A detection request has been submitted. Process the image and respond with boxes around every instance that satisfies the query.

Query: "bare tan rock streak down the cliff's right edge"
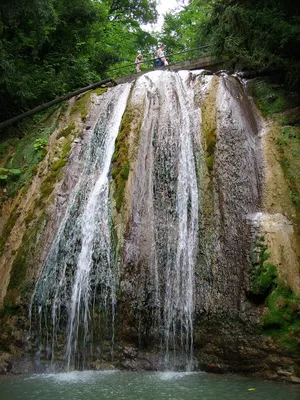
[261,121,300,295]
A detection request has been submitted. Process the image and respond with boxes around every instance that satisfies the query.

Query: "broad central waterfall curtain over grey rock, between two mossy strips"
[123,71,200,368]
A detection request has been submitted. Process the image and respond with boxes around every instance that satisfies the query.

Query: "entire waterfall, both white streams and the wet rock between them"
[31,71,261,370]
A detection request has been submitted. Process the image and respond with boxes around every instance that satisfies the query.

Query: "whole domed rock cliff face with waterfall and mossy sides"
[0,71,300,382]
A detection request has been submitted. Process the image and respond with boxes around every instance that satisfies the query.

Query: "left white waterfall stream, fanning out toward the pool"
[31,85,130,369]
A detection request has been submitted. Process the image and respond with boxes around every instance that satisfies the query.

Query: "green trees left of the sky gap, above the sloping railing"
[0,0,157,121]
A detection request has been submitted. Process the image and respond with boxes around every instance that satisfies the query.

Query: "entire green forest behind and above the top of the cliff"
[0,0,300,121]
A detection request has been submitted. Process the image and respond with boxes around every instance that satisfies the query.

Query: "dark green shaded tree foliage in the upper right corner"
[198,0,300,85]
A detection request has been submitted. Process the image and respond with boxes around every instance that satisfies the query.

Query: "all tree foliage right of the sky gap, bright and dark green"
[160,0,300,87]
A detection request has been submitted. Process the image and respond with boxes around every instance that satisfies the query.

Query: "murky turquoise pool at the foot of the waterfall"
[0,371,300,400]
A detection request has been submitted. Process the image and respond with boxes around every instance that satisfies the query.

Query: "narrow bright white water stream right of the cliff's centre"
[164,70,198,369]
